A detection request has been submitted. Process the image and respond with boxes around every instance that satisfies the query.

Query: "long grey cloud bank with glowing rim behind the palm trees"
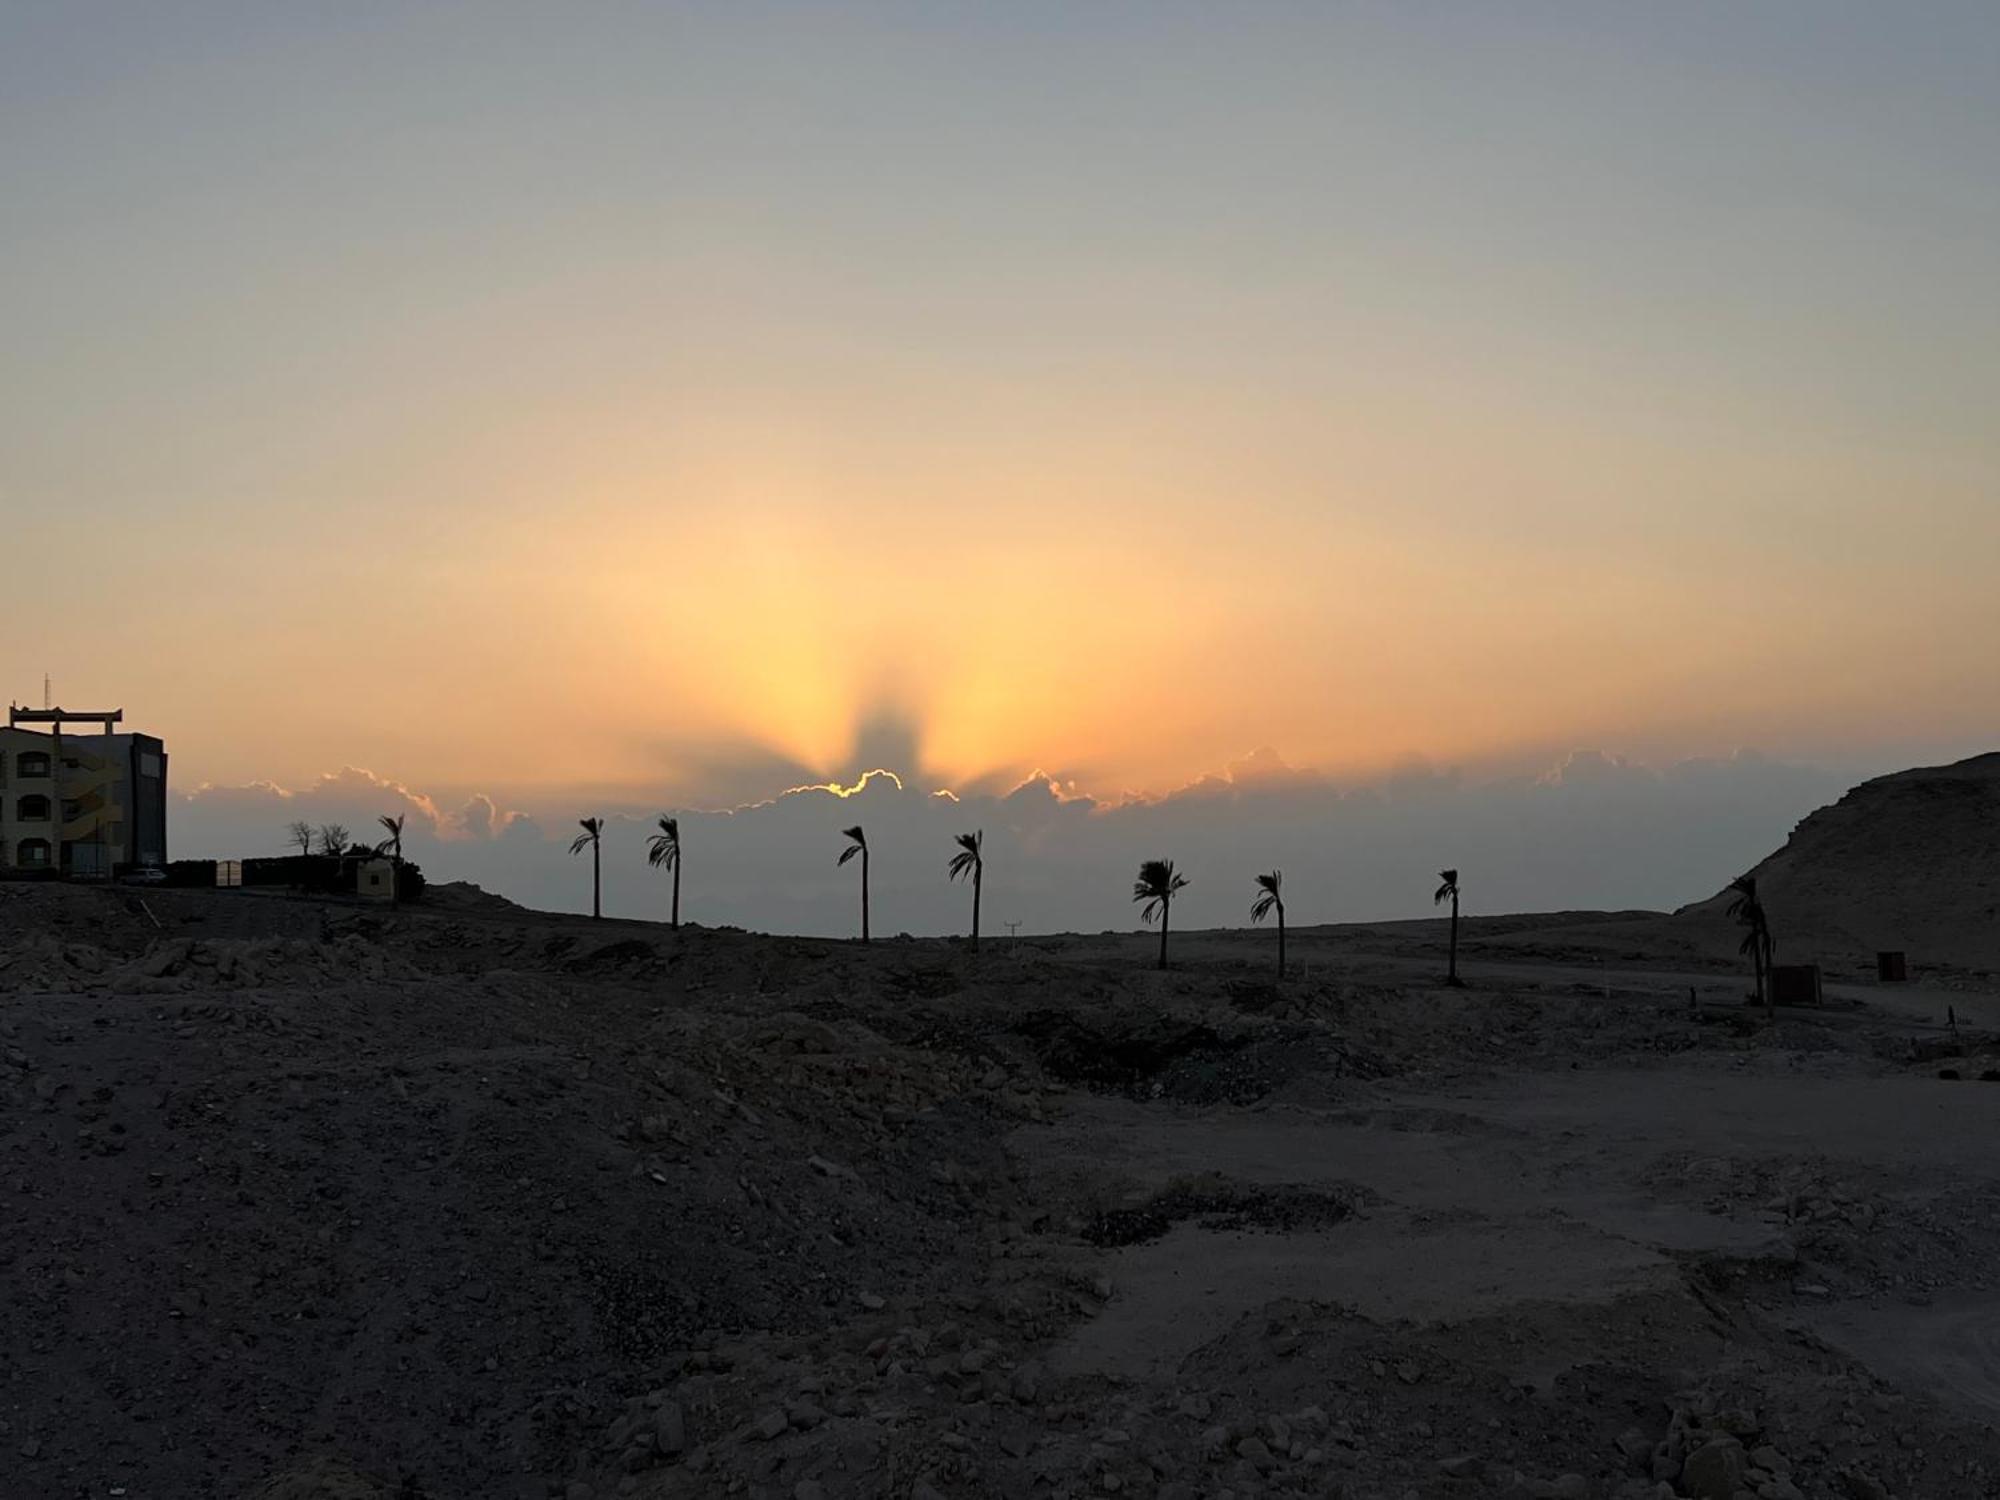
[170,750,1854,936]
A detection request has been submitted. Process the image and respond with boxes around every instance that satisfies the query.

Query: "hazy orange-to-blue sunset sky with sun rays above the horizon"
[0,0,2000,930]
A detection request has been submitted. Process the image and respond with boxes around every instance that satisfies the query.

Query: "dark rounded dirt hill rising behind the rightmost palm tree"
[1670,752,2000,972]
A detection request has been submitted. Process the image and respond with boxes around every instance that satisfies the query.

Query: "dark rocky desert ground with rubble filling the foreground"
[0,886,2000,1500]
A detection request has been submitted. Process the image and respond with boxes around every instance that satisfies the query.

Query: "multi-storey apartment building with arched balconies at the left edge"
[0,708,166,880]
